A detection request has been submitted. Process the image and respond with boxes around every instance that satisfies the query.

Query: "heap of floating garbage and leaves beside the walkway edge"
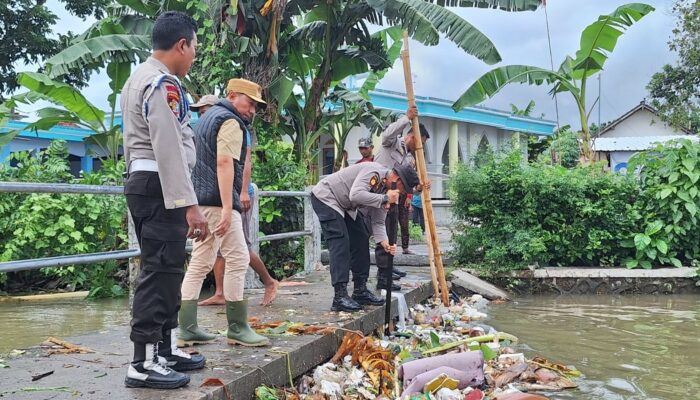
[256,295,580,400]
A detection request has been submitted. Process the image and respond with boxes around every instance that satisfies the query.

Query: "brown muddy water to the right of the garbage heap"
[487,295,700,400]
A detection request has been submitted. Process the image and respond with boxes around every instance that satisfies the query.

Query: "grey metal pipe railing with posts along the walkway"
[0,182,321,287]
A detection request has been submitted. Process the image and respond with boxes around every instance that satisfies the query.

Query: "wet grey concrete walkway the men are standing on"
[0,266,431,400]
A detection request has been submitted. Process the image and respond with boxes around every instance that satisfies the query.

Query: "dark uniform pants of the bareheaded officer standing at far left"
[124,171,187,343]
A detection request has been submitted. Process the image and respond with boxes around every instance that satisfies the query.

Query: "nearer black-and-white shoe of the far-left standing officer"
[124,343,190,389]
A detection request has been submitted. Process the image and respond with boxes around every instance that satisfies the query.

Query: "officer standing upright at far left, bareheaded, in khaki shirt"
[121,12,208,389]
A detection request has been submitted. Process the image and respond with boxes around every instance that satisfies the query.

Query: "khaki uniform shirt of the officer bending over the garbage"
[311,162,388,242]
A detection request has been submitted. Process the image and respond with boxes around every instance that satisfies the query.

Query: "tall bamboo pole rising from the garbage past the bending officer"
[401,31,450,306]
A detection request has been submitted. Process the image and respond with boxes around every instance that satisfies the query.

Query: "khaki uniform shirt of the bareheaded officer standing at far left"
[121,57,197,209]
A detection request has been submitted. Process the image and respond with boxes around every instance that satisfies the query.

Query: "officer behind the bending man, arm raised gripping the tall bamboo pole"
[374,107,430,291]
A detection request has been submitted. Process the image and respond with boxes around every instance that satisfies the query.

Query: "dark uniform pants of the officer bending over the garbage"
[311,195,369,286]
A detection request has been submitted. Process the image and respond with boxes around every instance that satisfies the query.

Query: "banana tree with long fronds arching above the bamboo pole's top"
[287,0,541,136]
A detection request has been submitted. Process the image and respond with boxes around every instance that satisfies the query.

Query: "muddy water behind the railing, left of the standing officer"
[0,297,130,354]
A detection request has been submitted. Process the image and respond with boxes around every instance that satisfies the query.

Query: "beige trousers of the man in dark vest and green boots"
[182,206,250,301]
